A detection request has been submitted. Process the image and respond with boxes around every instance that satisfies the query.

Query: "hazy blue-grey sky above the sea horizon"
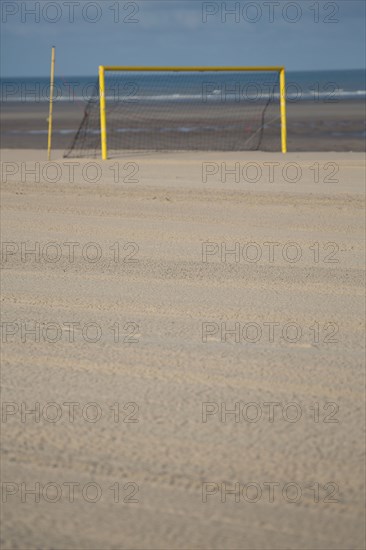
[1,0,366,77]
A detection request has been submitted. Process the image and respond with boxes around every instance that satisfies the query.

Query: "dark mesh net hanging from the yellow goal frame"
[65,67,285,158]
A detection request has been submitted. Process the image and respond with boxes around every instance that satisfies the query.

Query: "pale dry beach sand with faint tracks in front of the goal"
[2,150,365,550]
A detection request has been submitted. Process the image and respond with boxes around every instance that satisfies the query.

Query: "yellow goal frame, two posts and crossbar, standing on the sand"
[99,65,287,160]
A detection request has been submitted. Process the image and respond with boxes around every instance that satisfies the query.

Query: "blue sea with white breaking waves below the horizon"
[0,69,366,103]
